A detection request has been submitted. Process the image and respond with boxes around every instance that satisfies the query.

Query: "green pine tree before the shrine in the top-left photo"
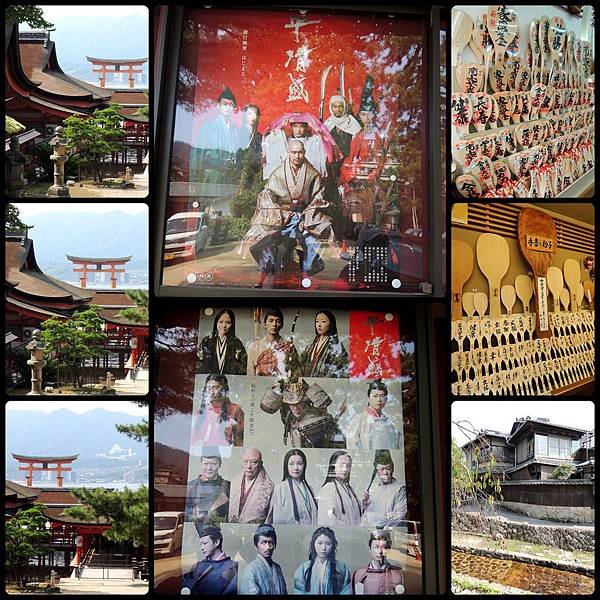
[64,104,125,182]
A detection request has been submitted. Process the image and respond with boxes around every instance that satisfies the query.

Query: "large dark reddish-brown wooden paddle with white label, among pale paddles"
[517,208,556,338]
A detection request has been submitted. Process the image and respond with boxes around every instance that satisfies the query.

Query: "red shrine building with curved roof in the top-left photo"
[4,25,150,174]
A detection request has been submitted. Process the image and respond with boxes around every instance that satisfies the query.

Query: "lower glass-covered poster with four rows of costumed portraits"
[155,306,422,595]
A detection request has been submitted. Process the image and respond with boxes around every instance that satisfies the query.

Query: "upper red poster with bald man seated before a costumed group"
[159,8,441,294]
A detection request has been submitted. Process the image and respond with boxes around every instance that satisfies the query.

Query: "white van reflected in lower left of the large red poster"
[165,212,209,261]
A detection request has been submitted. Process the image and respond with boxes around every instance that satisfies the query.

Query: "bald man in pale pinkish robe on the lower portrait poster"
[229,448,273,523]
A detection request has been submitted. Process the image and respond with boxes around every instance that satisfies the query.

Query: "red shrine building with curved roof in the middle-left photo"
[5,232,149,377]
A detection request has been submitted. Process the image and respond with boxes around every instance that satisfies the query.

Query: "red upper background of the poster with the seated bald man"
[178,9,427,141]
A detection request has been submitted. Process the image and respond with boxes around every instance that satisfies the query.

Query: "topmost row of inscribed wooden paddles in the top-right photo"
[452,5,592,92]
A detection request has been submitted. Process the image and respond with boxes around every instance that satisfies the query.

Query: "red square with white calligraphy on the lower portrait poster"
[350,310,400,379]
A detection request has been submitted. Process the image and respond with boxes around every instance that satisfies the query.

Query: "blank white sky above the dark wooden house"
[452,400,594,446]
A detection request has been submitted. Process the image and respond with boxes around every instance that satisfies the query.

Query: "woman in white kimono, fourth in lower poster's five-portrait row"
[318,450,362,527]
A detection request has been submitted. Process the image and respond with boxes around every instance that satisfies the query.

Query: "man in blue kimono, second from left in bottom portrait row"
[240,525,287,596]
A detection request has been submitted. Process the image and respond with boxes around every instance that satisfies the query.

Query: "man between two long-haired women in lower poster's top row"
[248,308,300,377]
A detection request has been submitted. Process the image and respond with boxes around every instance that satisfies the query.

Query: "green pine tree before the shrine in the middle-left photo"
[42,305,106,388]
